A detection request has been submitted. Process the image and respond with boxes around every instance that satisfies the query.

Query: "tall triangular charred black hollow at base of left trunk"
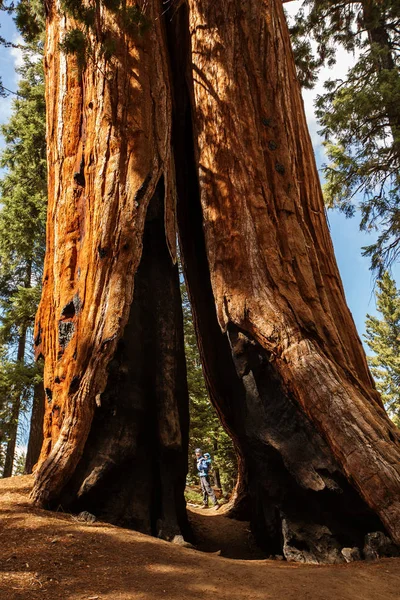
[50,181,189,539]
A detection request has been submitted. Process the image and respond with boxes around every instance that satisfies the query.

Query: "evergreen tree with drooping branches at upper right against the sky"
[292,0,400,274]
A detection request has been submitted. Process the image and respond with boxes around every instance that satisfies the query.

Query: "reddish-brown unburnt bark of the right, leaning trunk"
[184,0,400,542]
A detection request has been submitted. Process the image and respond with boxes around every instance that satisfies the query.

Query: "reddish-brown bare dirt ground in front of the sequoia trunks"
[0,476,400,600]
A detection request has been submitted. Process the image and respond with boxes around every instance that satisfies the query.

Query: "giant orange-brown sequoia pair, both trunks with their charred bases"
[32,0,400,561]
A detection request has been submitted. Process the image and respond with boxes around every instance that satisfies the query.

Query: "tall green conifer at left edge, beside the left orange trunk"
[0,27,47,477]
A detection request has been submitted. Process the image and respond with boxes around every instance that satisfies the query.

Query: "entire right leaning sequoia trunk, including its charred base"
[183,0,400,560]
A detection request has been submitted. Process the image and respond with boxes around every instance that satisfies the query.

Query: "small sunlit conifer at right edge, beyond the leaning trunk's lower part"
[364,272,400,427]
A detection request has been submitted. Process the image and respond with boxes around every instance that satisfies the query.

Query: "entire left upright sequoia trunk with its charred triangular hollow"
[29,1,188,537]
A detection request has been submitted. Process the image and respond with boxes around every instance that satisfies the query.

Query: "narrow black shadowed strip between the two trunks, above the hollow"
[167,4,244,454]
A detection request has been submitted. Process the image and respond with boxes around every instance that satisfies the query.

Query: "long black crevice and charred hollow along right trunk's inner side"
[167,5,383,562]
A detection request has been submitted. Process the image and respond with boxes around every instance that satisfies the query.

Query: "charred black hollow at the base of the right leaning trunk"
[228,326,390,563]
